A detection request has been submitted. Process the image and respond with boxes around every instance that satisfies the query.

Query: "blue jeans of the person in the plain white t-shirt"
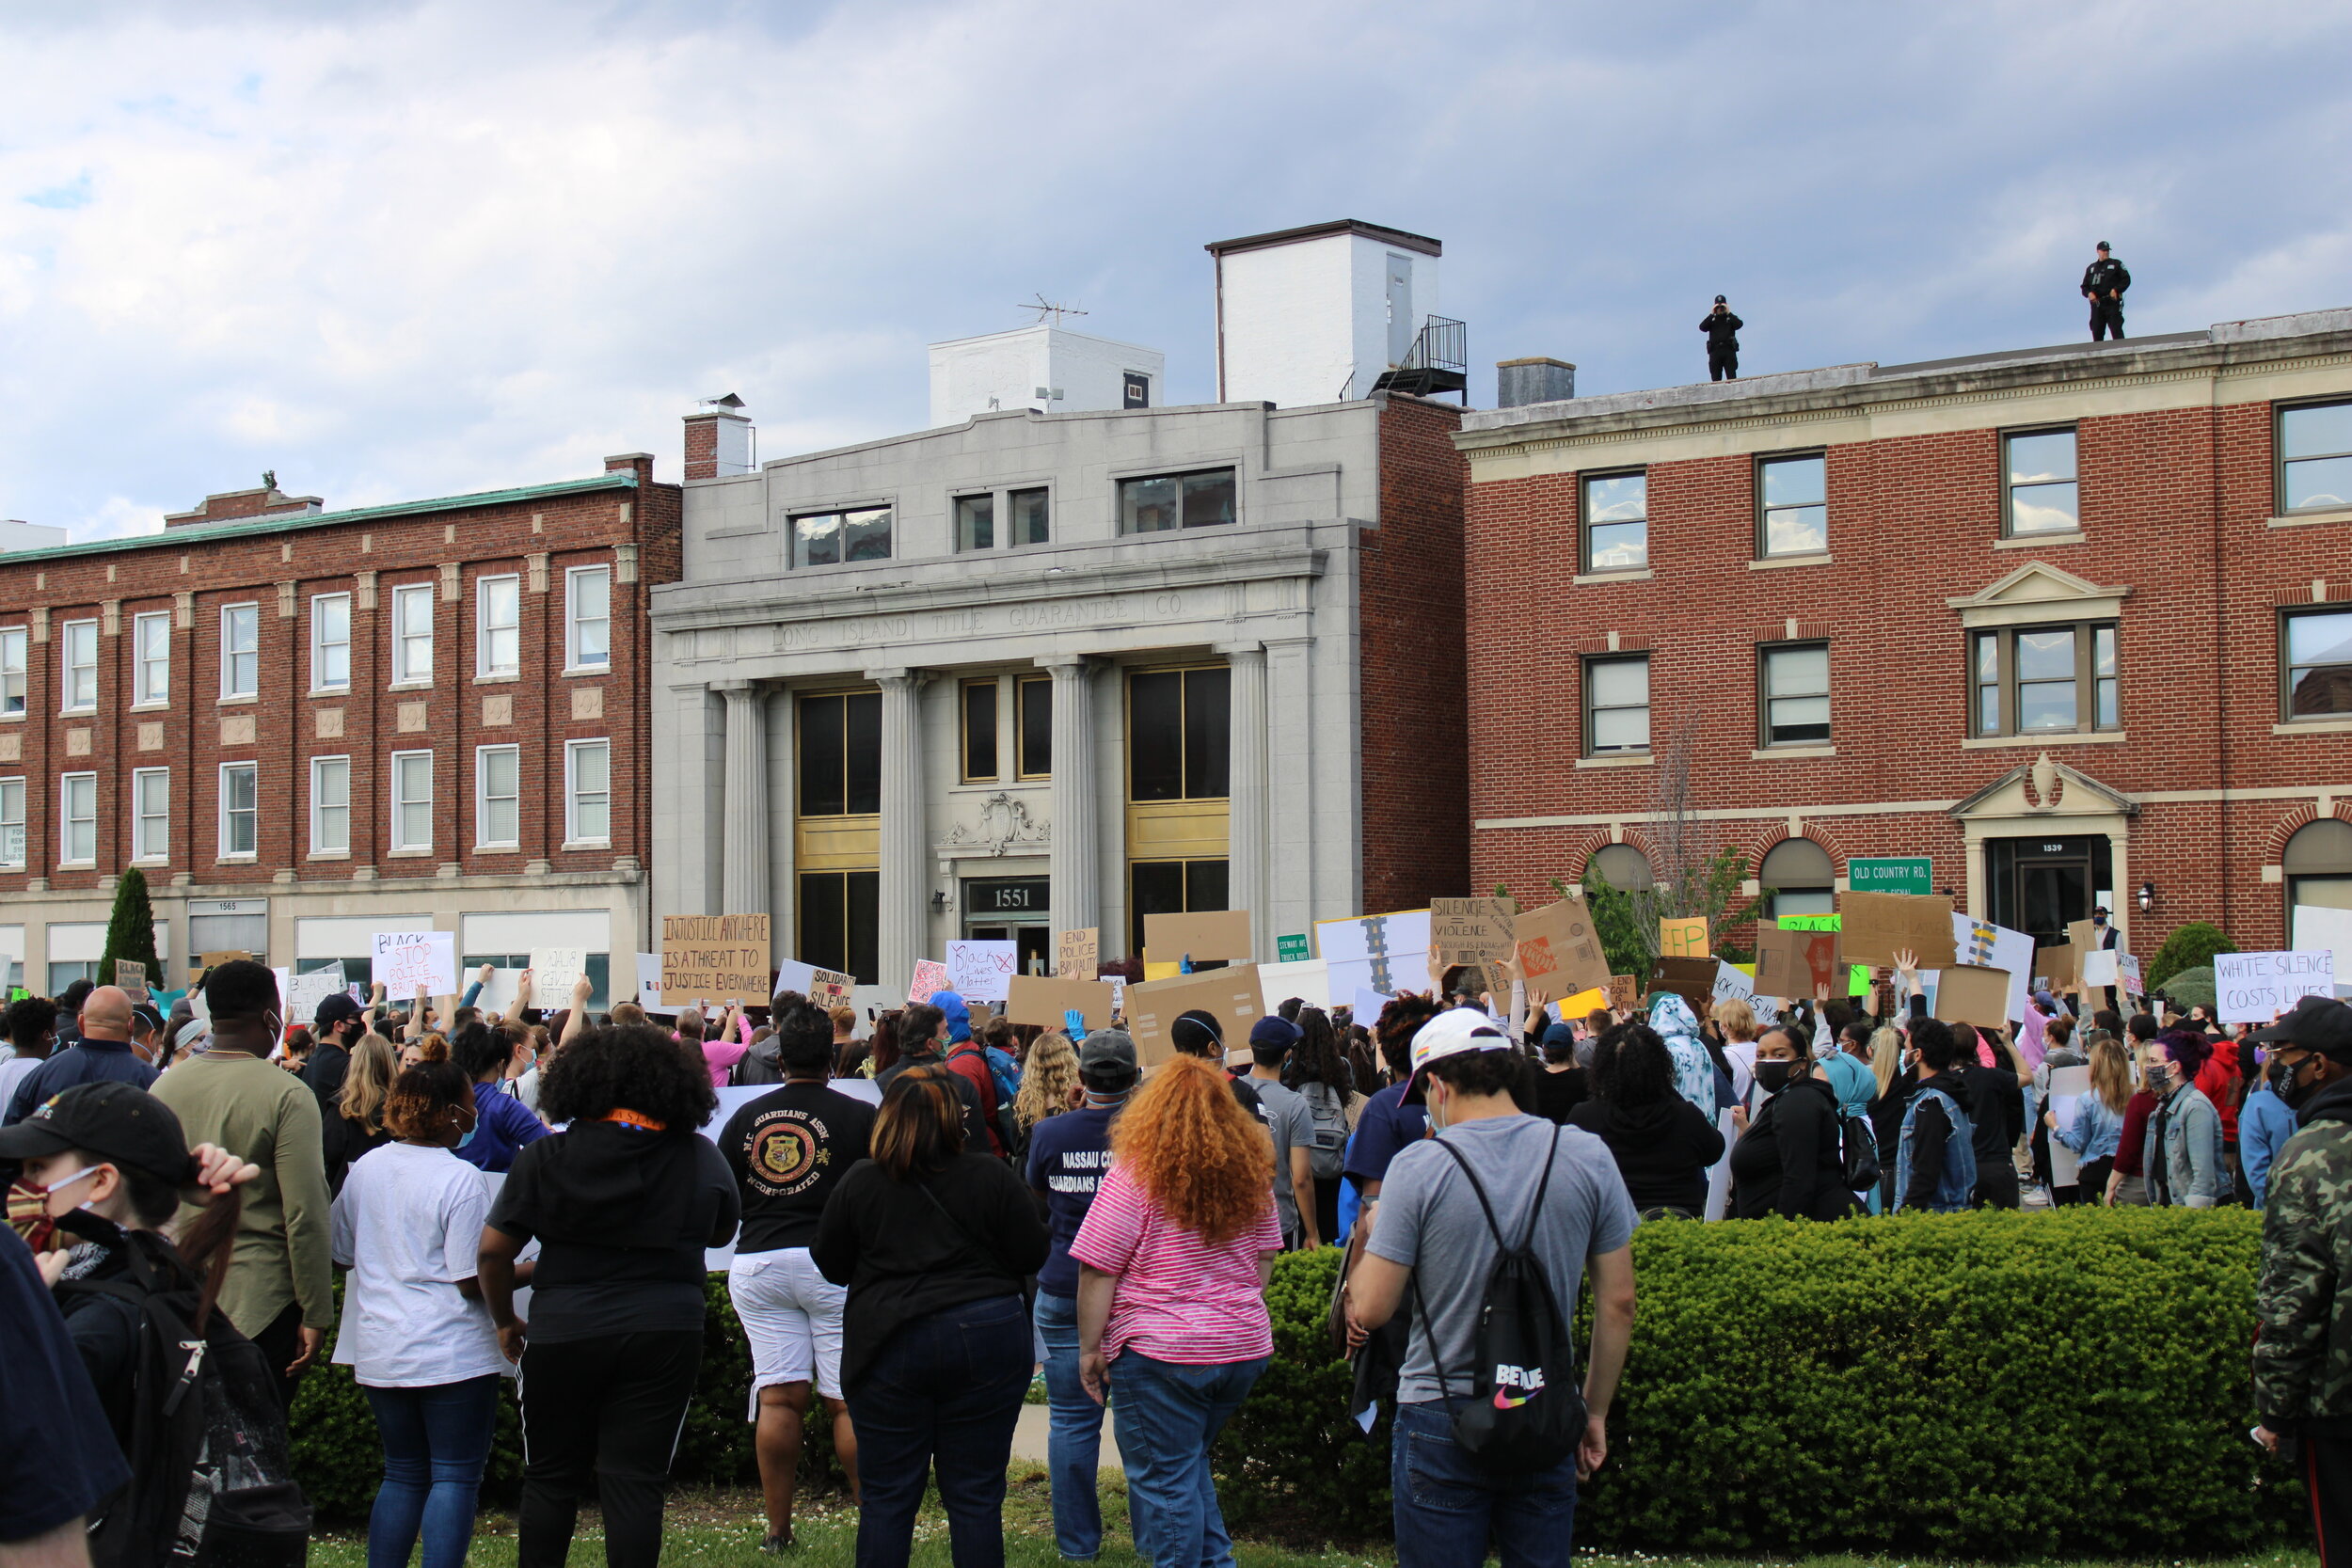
[367,1373,501,1568]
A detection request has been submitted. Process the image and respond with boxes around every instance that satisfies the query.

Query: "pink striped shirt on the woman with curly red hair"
[1071,1166,1282,1366]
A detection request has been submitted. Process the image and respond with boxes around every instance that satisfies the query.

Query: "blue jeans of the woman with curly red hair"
[1110,1350,1268,1568]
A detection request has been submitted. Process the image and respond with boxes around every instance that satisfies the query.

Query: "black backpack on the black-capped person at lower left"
[56,1232,310,1568]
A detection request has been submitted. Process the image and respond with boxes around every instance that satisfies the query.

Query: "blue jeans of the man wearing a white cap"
[1388,1399,1576,1568]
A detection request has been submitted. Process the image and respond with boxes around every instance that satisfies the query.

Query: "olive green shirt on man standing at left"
[153,1051,334,1336]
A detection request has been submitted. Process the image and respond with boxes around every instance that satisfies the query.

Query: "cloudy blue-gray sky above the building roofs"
[0,0,2352,538]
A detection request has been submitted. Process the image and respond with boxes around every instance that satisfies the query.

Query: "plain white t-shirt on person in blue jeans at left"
[334,1143,513,1389]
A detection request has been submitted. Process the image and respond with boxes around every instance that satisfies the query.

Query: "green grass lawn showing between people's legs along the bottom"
[310,1460,2319,1568]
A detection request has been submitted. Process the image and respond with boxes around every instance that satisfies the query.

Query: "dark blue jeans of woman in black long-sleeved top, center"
[850,1295,1035,1568]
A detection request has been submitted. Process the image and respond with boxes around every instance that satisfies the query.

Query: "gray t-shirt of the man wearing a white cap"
[1372,1117,1635,1403]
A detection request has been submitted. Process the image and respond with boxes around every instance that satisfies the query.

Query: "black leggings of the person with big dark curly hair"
[516,1328,704,1568]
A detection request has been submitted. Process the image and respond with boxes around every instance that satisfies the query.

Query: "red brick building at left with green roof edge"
[0,453,680,994]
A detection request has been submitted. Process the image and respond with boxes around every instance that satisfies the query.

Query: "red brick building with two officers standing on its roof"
[1456,310,2352,957]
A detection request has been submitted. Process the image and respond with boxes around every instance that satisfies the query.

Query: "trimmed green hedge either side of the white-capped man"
[1218,1209,2303,1559]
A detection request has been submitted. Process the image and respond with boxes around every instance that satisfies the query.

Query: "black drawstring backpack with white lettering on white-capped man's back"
[1414,1129,1585,1477]
